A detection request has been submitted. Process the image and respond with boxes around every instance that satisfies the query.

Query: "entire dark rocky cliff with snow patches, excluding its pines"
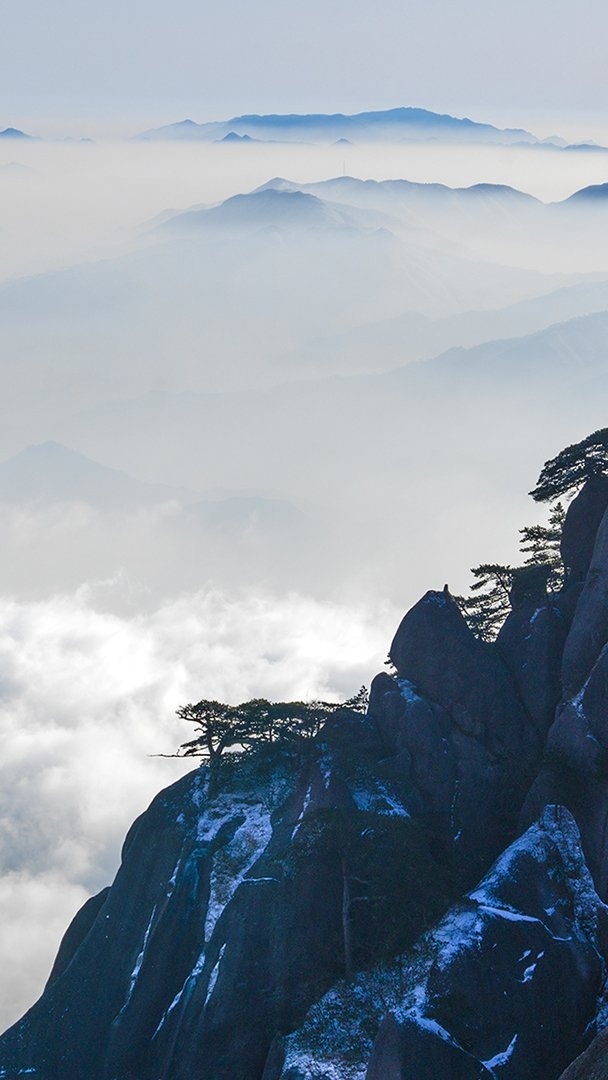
[0,478,608,1080]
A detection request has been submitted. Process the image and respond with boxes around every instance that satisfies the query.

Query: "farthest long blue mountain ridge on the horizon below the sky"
[136,107,562,147]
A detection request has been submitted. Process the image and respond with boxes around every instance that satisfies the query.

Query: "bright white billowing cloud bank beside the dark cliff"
[0,590,400,1028]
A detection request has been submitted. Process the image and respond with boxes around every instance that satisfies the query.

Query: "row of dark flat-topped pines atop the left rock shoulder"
[177,687,367,762]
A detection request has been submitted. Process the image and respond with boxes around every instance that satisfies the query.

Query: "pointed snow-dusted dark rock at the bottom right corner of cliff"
[274,807,607,1080]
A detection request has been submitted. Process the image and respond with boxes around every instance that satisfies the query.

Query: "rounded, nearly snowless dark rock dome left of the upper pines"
[369,592,541,885]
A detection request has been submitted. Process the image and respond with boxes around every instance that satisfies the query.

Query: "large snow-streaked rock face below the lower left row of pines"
[0,720,451,1080]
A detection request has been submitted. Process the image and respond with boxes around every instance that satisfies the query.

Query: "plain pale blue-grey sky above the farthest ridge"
[0,0,608,135]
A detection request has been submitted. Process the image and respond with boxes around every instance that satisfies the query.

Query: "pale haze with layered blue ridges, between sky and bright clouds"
[0,108,608,626]
